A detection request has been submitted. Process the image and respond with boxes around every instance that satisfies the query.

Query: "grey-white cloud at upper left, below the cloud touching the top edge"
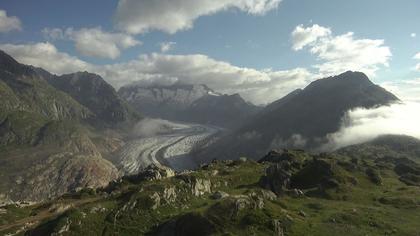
[42,27,141,59]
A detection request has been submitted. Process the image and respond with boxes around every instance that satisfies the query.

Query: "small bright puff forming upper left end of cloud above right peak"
[292,24,331,51]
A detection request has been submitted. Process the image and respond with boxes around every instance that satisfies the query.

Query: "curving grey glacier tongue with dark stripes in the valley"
[114,121,221,174]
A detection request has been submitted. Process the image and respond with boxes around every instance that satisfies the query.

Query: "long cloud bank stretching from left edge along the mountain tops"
[0,43,314,104]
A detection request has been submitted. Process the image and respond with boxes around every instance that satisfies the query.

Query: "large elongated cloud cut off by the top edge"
[114,0,281,34]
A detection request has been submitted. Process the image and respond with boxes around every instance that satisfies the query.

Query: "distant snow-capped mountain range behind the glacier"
[118,84,259,128]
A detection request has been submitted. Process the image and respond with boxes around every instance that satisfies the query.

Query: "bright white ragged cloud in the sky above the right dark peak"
[292,25,392,76]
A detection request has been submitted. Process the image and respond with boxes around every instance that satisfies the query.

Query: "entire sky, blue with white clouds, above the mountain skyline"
[0,0,420,104]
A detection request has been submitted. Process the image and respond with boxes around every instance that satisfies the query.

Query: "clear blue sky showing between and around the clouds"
[0,0,420,103]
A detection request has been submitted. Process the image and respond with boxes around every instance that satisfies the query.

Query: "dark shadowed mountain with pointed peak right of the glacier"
[201,72,399,161]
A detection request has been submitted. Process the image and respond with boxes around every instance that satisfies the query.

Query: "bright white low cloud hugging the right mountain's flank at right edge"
[323,103,420,150]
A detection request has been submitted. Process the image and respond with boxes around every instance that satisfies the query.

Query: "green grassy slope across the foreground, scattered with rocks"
[0,150,420,235]
